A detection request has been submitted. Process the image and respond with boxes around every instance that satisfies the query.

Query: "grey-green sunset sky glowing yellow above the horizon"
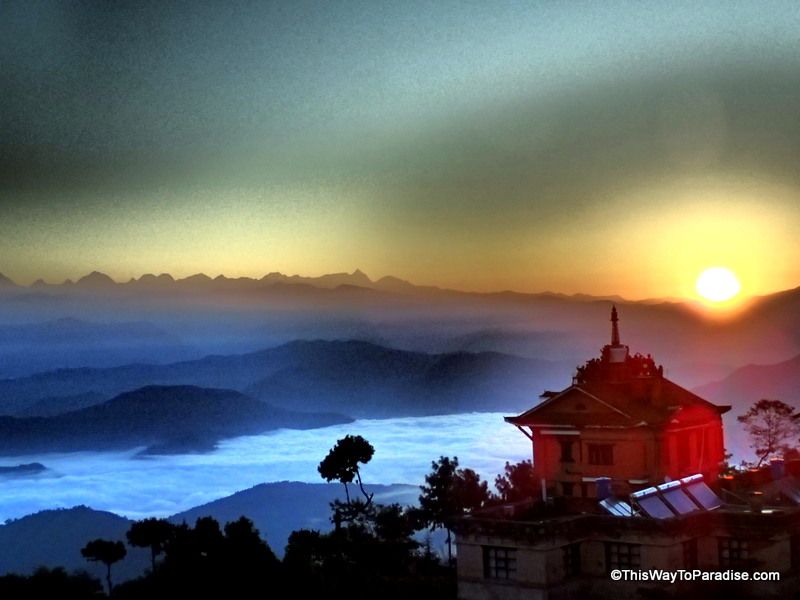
[0,0,800,299]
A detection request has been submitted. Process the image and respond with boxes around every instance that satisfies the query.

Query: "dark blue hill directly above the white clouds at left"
[0,386,351,455]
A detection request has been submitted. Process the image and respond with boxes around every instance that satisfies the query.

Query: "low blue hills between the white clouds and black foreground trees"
[0,481,419,582]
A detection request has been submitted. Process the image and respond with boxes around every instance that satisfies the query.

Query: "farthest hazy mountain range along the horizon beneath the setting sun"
[0,270,800,386]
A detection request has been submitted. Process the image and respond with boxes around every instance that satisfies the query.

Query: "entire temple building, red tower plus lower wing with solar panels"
[452,308,800,600]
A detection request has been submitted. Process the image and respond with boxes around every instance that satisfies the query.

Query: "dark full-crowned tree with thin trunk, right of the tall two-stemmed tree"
[419,456,490,563]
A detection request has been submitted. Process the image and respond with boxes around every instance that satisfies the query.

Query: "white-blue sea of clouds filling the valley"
[0,413,531,521]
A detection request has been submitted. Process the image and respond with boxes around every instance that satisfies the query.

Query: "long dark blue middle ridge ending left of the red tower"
[0,341,571,420]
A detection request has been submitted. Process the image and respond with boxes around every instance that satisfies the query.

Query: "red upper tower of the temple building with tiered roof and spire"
[506,307,730,498]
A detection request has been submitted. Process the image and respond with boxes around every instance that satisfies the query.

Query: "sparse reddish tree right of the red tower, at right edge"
[736,398,798,467]
